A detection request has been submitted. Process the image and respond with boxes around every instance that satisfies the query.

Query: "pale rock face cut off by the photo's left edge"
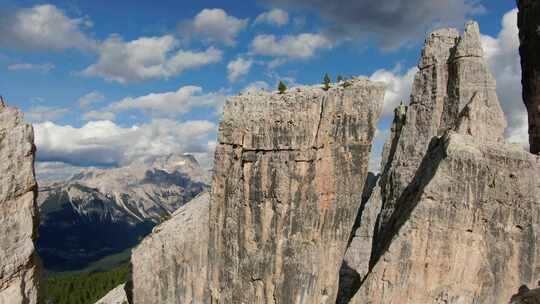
[0,98,41,304]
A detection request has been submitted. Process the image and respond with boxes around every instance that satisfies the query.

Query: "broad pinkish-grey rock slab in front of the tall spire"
[350,131,540,304]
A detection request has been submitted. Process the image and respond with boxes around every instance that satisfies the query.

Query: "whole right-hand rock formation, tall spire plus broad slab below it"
[342,23,540,304]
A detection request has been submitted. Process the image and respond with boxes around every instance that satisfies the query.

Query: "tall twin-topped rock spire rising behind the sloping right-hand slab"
[345,23,506,296]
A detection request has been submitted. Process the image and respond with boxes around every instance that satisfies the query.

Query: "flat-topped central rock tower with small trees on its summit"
[208,78,384,304]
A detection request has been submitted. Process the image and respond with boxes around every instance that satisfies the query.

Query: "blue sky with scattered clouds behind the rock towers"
[0,0,526,175]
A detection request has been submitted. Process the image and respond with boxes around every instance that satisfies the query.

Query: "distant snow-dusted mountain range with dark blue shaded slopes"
[37,155,210,272]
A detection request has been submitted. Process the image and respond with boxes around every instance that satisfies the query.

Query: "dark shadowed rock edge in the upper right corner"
[517,0,540,154]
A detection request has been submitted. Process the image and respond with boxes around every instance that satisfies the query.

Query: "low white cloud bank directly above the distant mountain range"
[34,119,216,166]
